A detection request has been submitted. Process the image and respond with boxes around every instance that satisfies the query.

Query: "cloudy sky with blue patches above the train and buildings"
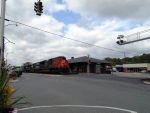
[1,0,150,66]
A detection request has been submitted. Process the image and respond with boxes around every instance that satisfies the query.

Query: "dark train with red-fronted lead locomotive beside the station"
[23,56,70,74]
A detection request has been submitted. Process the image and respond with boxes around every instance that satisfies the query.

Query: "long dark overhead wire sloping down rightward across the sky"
[5,19,136,54]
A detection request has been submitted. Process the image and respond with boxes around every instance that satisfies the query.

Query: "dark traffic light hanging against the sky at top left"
[34,1,43,16]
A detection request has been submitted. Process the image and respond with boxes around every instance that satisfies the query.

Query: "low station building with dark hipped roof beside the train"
[68,56,111,73]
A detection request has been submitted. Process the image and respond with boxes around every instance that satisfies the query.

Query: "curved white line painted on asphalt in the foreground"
[18,105,137,113]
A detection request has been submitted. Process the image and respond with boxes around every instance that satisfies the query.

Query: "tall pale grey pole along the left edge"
[0,0,6,73]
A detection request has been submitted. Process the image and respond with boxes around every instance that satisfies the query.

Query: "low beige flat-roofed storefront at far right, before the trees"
[123,63,150,72]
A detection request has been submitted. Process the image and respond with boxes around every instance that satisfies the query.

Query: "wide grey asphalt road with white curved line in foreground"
[11,73,150,113]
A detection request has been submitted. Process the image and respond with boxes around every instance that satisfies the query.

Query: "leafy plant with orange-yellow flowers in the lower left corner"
[0,69,30,113]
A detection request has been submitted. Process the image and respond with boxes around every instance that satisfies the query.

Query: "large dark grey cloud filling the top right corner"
[63,0,150,20]
